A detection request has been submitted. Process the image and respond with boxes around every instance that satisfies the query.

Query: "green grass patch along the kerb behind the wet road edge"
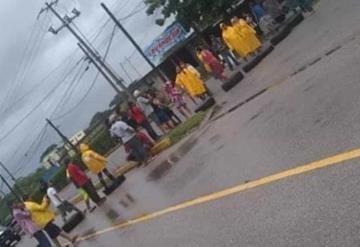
[167,112,206,145]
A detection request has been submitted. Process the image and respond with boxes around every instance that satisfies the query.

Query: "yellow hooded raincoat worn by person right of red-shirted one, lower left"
[80,143,107,174]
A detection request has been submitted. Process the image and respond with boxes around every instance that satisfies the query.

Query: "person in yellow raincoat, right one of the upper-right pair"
[231,17,262,52]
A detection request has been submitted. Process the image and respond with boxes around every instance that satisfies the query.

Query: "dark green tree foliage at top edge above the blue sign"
[145,0,236,30]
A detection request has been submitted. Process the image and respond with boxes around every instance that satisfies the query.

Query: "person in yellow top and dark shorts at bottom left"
[24,195,78,247]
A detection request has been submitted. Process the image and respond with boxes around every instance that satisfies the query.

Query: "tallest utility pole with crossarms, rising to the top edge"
[40,0,132,97]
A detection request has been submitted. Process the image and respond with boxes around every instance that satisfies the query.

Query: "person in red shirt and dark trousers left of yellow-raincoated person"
[65,159,106,206]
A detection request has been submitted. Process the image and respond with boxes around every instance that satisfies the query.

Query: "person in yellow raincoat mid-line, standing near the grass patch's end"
[175,63,207,99]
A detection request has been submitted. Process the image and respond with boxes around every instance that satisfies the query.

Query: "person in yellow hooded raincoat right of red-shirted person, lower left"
[80,143,116,189]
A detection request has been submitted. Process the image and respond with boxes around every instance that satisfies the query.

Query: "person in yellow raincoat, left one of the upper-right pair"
[220,23,251,60]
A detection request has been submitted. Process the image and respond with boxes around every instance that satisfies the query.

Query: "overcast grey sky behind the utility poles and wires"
[0,0,172,180]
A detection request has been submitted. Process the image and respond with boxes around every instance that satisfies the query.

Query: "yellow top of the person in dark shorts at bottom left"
[24,197,55,228]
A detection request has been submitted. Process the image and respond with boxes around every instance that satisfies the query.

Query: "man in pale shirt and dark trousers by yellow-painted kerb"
[109,114,149,165]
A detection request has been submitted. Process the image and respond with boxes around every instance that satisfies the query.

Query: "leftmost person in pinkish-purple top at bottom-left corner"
[11,202,51,247]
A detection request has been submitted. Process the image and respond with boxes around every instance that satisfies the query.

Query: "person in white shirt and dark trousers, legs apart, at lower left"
[46,182,82,223]
